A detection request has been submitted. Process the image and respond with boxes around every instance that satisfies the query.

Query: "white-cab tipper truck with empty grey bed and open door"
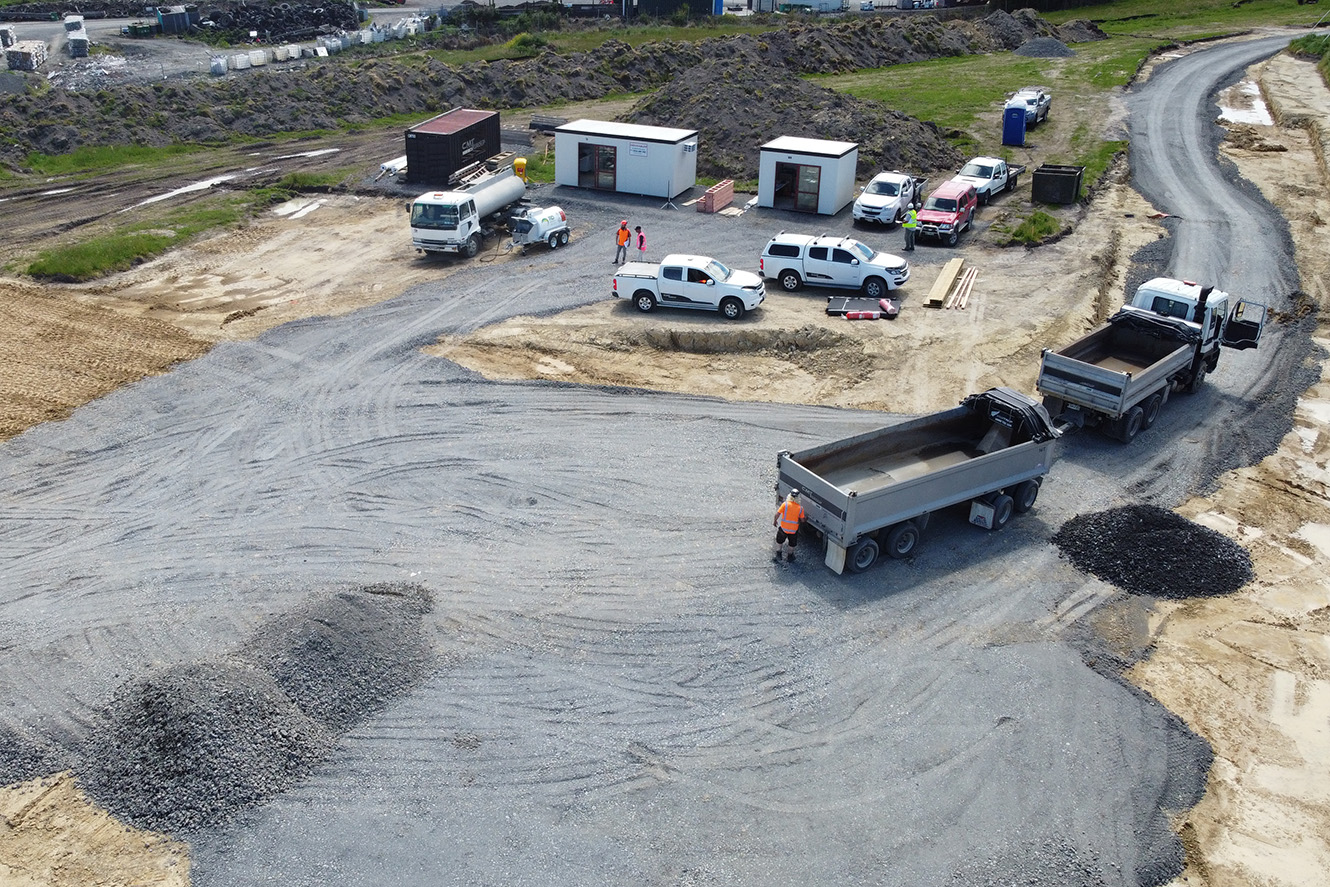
[1035,278,1266,443]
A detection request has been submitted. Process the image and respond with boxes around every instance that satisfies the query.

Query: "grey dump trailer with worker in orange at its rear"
[775,388,1060,573]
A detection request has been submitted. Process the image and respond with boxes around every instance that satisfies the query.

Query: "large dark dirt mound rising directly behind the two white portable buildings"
[628,59,962,180]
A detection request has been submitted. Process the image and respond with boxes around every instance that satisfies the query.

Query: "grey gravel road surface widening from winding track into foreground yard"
[0,31,1309,887]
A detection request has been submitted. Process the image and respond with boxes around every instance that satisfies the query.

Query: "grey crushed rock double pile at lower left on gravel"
[80,585,431,832]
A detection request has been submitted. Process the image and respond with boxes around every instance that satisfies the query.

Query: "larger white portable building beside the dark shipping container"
[555,120,697,199]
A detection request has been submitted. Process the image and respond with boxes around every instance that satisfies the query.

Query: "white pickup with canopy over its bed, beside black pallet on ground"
[758,231,910,299]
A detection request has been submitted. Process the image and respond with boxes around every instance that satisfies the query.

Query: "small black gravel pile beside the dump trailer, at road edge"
[1053,505,1253,598]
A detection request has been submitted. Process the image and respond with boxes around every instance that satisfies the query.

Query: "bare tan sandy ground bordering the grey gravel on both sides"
[0,39,1330,884]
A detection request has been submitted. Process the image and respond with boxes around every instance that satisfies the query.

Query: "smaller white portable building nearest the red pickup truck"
[757,136,859,215]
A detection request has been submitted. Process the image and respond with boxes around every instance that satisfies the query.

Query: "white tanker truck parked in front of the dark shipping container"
[411,165,527,258]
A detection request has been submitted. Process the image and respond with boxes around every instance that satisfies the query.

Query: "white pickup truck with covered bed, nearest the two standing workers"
[612,255,766,320]
